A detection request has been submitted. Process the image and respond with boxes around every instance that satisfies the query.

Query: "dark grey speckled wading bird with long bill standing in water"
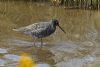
[13,19,66,46]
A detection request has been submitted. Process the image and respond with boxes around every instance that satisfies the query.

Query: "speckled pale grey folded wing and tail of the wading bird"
[13,22,49,35]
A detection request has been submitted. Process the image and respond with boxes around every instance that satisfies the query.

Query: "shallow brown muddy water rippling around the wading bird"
[0,2,100,67]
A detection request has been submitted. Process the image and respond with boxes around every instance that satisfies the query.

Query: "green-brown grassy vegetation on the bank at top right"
[52,0,100,9]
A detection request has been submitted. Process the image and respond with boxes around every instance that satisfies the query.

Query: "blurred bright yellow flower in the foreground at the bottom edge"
[18,53,35,67]
